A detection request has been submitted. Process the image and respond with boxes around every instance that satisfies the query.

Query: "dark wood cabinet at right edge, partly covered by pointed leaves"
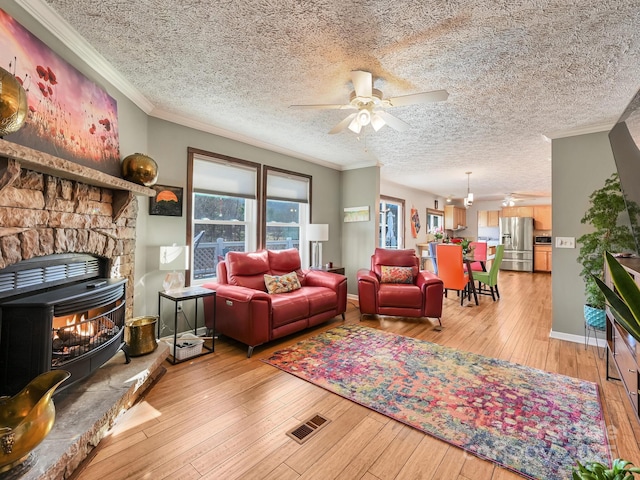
[605,258,640,422]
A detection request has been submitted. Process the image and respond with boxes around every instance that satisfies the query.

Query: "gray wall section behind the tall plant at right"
[551,132,616,341]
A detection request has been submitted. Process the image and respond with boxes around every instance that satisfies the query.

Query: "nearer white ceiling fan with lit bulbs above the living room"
[290,70,449,134]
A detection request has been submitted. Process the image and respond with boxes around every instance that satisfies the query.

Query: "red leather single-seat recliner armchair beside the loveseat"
[357,248,444,326]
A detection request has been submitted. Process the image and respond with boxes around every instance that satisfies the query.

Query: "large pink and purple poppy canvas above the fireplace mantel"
[0,9,121,177]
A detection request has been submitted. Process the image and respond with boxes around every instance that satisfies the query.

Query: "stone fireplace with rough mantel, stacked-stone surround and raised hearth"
[0,139,168,479]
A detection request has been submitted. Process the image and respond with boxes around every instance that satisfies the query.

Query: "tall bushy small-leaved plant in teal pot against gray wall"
[577,173,640,309]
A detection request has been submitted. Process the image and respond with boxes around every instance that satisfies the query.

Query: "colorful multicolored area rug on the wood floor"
[264,325,611,480]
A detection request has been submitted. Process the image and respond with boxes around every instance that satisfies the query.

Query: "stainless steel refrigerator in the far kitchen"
[500,217,533,272]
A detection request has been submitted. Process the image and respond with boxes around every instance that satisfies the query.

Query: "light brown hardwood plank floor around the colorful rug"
[72,272,640,480]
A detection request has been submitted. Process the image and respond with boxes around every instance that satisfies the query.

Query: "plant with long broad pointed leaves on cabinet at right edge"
[593,252,640,342]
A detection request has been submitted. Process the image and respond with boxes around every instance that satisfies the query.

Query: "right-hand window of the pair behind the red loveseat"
[263,167,311,265]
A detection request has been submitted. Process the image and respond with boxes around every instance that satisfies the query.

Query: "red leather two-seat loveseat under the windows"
[203,249,347,357]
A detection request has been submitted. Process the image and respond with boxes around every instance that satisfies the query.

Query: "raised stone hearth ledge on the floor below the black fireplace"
[0,342,169,480]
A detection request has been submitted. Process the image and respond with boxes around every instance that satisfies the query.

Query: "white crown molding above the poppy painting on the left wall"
[15,0,153,114]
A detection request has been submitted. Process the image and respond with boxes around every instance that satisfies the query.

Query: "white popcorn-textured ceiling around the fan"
[30,0,640,199]
